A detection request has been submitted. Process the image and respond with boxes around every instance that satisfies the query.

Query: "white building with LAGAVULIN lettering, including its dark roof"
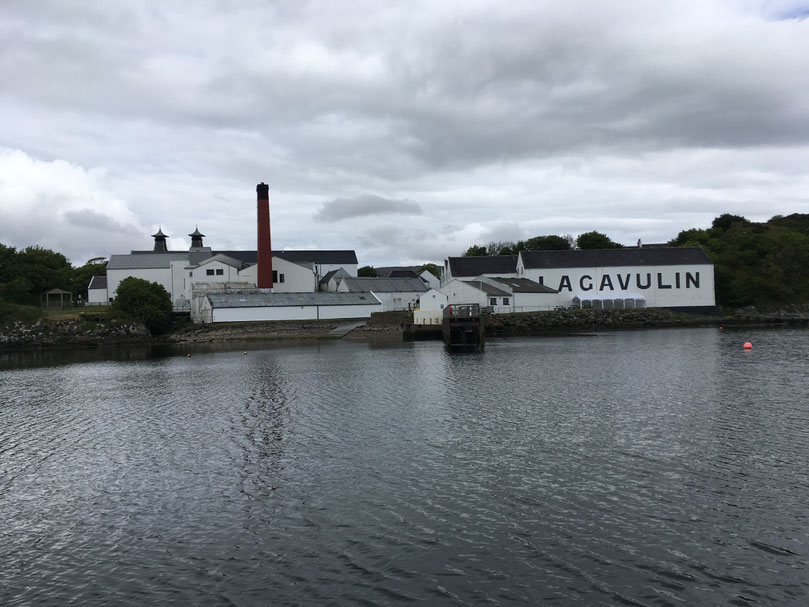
[516,247,716,313]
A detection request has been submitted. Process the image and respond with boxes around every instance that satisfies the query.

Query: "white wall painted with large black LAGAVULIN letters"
[522,264,716,308]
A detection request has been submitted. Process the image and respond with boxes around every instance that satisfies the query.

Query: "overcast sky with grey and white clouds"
[0,0,809,266]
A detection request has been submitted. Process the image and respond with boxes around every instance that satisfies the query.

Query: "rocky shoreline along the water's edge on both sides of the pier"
[0,305,809,349]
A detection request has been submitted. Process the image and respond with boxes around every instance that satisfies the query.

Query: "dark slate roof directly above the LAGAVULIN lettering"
[520,247,713,269]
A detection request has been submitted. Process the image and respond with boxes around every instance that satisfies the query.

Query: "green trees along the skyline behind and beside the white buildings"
[0,213,809,308]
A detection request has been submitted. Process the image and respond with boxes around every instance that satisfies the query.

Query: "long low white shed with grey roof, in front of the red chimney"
[191,291,382,323]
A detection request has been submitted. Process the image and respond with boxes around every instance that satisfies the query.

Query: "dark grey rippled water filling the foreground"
[0,329,809,605]
